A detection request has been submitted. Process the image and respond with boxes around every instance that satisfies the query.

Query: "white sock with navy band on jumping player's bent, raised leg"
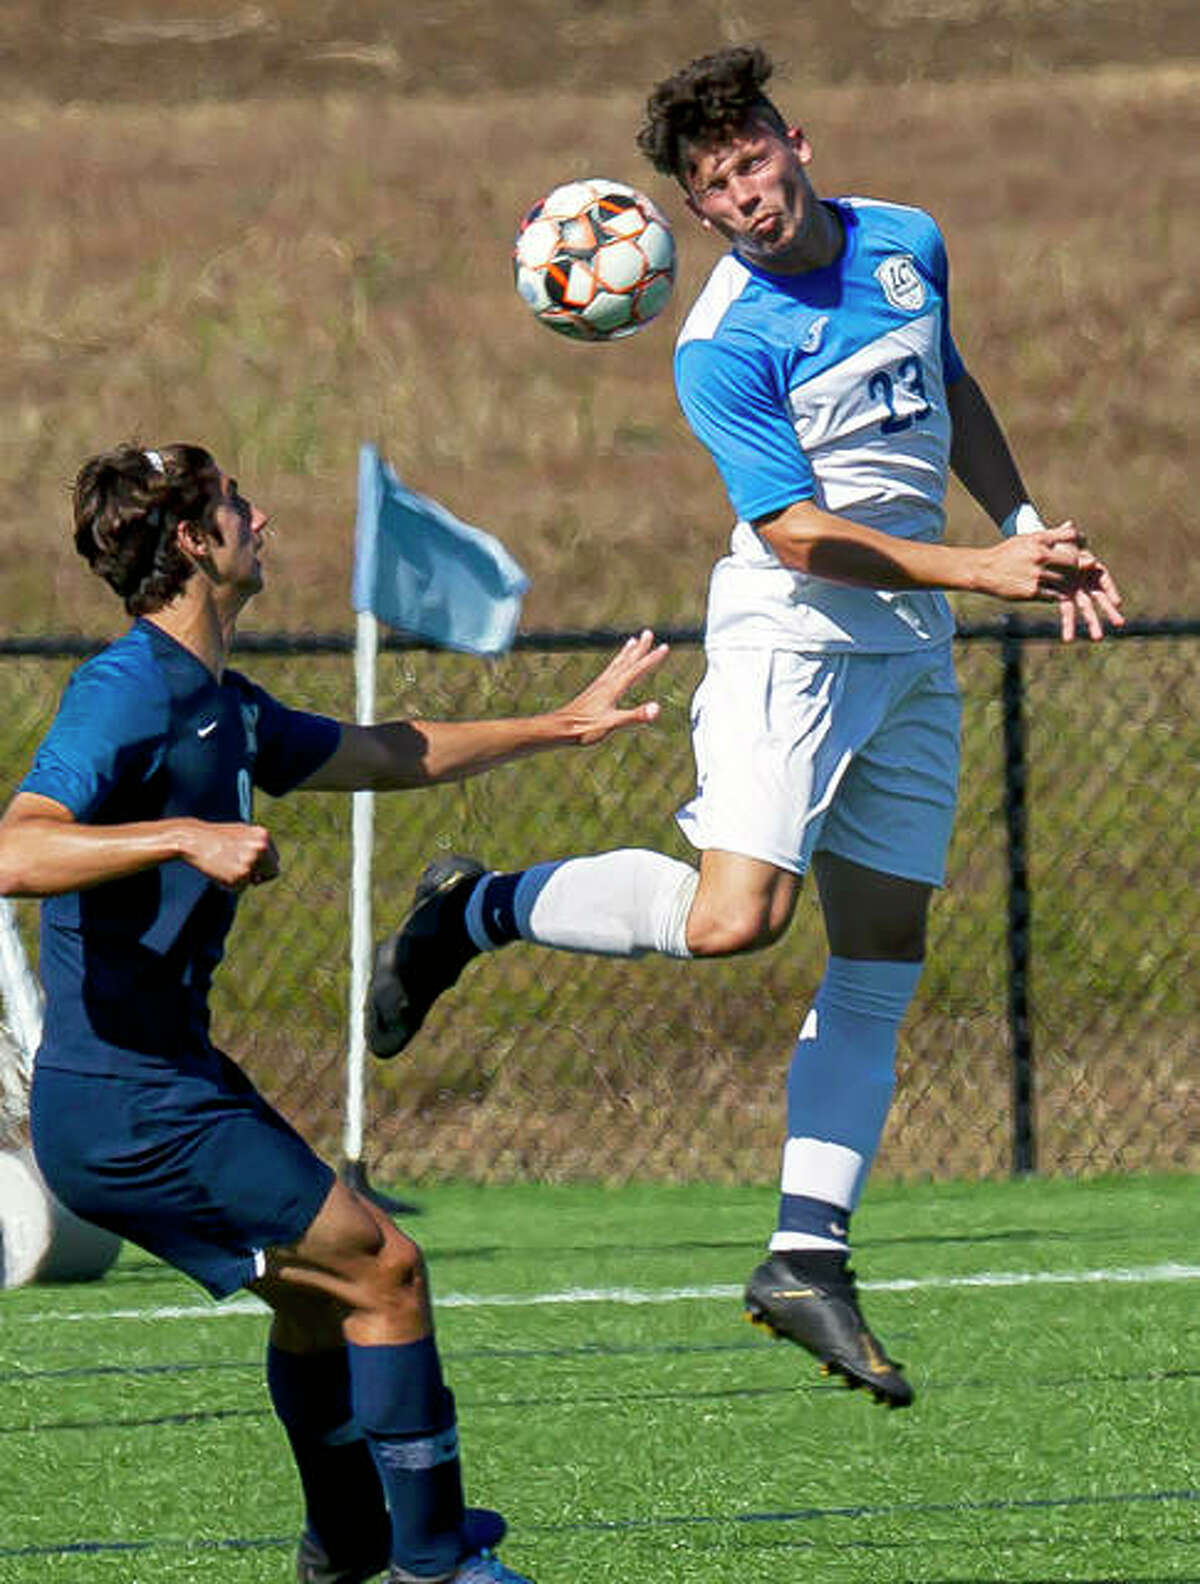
[465,847,700,957]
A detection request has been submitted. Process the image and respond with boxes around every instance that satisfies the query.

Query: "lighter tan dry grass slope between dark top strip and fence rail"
[0,52,1200,632]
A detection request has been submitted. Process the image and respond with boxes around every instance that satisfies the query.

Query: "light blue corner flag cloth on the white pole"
[351,445,529,654]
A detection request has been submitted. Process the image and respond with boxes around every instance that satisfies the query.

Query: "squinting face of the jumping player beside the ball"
[687,120,817,271]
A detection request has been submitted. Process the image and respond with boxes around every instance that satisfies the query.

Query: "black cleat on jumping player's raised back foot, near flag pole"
[367,852,486,1057]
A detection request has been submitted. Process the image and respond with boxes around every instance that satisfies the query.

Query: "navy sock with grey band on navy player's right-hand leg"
[348,1337,464,1579]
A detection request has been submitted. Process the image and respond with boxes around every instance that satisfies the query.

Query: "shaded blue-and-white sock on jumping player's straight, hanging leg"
[771,957,921,1248]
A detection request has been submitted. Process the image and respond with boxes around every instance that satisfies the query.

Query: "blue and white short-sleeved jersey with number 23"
[674,198,964,653]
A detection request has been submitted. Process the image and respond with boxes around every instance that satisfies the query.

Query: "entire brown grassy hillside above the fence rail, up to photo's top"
[0,0,1200,634]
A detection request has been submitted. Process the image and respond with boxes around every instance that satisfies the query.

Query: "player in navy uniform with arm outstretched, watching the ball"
[0,445,665,1584]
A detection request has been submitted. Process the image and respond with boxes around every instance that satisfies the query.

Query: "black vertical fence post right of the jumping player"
[1001,615,1037,1177]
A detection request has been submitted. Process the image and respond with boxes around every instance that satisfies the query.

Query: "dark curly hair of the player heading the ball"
[638,44,787,187]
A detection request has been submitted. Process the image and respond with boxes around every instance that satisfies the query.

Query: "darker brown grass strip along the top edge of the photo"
[0,0,1200,103]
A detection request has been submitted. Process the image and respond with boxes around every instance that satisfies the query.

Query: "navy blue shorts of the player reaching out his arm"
[30,1052,334,1297]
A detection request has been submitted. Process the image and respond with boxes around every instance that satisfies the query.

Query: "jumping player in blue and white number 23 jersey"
[369,48,1121,1407]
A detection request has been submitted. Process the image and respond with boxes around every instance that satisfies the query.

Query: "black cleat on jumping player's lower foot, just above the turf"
[746,1248,913,1408]
